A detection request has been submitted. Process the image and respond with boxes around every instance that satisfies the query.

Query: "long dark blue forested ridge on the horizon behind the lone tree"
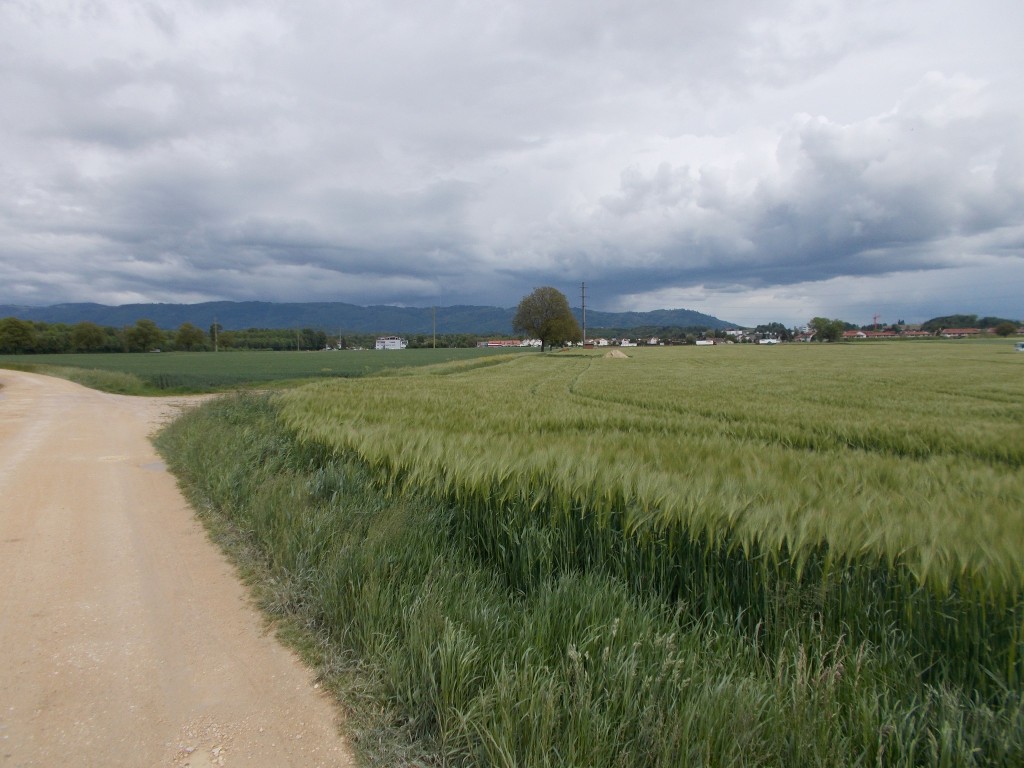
[0,301,733,335]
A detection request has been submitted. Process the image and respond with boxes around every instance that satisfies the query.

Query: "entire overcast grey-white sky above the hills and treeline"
[0,0,1024,326]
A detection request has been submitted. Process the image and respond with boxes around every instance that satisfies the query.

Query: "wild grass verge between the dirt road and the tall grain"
[158,395,1024,766]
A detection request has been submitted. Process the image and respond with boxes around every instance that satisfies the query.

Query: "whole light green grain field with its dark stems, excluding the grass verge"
[284,343,1024,685]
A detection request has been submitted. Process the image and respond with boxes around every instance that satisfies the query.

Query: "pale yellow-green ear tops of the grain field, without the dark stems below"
[285,345,1024,606]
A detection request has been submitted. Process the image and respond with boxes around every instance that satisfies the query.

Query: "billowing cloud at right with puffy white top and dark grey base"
[585,71,1024,313]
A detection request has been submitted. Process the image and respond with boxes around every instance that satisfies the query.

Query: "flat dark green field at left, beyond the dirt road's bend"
[0,349,520,393]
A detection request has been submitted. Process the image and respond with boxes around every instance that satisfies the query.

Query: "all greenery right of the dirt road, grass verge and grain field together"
[160,342,1024,766]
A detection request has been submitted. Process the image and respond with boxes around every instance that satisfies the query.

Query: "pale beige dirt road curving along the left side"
[0,371,353,768]
